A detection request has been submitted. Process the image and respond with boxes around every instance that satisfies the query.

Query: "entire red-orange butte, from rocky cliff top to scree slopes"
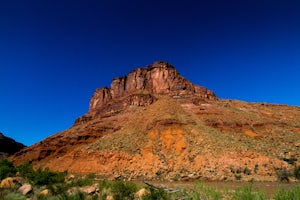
[12,62,300,180]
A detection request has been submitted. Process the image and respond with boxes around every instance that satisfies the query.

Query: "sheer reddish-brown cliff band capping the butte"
[89,61,217,113]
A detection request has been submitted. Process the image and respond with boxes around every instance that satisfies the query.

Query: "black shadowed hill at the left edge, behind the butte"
[0,132,25,159]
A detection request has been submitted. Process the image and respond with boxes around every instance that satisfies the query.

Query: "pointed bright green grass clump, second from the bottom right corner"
[233,183,267,200]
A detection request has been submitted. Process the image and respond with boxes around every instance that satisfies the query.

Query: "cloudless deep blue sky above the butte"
[0,0,300,145]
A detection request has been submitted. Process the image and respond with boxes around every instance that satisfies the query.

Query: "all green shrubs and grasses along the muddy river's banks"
[0,160,300,200]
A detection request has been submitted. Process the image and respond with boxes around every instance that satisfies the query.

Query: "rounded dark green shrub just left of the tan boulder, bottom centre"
[111,181,137,200]
